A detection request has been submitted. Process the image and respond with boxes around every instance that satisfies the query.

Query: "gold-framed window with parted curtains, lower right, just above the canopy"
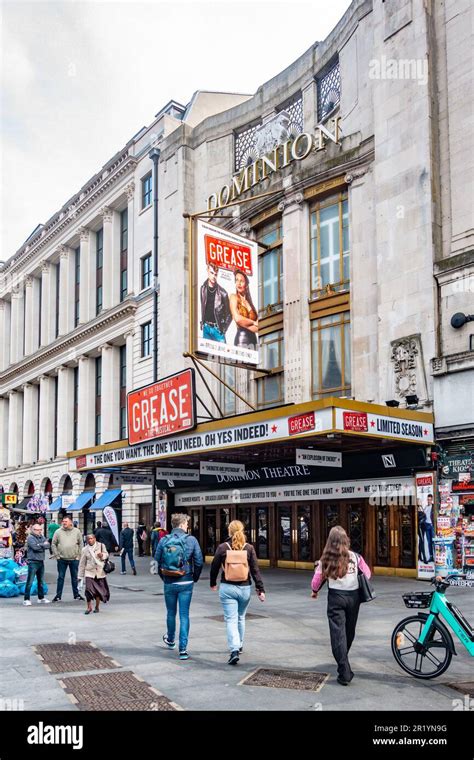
[311,311,351,398]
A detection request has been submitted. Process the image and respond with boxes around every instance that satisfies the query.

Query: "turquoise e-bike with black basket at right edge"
[392,575,474,679]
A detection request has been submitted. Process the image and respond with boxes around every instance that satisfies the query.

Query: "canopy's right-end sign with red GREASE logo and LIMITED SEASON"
[336,408,434,443]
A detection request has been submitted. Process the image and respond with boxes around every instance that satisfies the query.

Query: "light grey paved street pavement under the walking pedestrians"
[0,558,474,711]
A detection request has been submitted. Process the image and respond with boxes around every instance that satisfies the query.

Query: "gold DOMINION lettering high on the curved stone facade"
[207,116,340,212]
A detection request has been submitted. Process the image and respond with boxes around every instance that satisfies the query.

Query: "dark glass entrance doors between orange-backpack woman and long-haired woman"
[276,503,314,568]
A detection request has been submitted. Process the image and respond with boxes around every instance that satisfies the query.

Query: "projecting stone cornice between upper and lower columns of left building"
[0,299,137,394]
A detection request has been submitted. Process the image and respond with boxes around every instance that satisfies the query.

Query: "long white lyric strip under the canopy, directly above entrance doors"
[175,478,413,507]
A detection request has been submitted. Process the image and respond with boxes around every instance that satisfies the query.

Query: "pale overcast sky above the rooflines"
[0,0,350,260]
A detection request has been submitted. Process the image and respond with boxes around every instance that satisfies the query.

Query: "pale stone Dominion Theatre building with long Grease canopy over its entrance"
[64,0,460,574]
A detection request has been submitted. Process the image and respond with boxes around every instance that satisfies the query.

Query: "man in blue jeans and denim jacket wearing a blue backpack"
[155,514,203,660]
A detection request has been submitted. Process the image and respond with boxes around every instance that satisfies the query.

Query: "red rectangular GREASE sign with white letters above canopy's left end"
[128,369,196,445]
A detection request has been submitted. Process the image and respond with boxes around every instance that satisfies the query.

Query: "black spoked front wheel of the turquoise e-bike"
[392,615,453,680]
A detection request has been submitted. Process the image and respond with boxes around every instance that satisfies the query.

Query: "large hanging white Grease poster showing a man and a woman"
[197,220,259,365]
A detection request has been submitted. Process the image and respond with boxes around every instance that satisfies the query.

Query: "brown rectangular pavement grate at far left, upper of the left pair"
[33,641,120,673]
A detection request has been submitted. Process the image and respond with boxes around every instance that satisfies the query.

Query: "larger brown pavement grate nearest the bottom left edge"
[58,670,182,712]
